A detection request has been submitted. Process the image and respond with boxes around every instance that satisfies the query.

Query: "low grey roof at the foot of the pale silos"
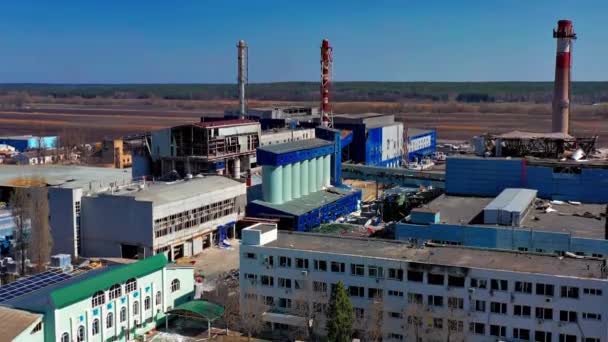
[253,187,354,216]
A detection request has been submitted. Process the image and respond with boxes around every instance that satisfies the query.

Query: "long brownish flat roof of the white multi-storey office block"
[264,231,606,279]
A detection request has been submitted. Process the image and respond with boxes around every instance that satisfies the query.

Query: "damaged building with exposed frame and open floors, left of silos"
[150,119,261,178]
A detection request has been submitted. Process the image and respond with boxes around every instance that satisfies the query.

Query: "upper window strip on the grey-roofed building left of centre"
[154,198,236,238]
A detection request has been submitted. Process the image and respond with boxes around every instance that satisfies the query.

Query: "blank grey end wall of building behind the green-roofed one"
[81,194,154,257]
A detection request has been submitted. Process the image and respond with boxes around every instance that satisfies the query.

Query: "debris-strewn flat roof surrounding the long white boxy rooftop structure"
[424,194,606,239]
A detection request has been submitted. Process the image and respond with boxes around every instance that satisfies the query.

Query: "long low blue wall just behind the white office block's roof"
[395,223,608,256]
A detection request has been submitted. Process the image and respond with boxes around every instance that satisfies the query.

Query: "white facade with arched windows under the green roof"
[52,267,194,342]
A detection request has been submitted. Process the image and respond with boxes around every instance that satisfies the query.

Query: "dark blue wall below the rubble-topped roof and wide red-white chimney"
[446,157,608,203]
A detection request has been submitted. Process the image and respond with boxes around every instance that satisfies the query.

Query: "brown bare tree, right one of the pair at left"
[29,187,53,272]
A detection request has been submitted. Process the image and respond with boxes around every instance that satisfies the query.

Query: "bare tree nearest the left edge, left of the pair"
[9,188,32,275]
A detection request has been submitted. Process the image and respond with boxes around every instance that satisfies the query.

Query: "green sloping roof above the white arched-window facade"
[51,253,168,309]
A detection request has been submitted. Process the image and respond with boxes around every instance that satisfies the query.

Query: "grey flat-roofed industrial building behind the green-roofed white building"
[81,176,246,260]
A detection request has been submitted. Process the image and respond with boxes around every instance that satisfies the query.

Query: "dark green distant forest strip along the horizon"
[0,82,608,104]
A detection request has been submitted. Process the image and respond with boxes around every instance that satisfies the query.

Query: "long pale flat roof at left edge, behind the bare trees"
[0,164,131,189]
